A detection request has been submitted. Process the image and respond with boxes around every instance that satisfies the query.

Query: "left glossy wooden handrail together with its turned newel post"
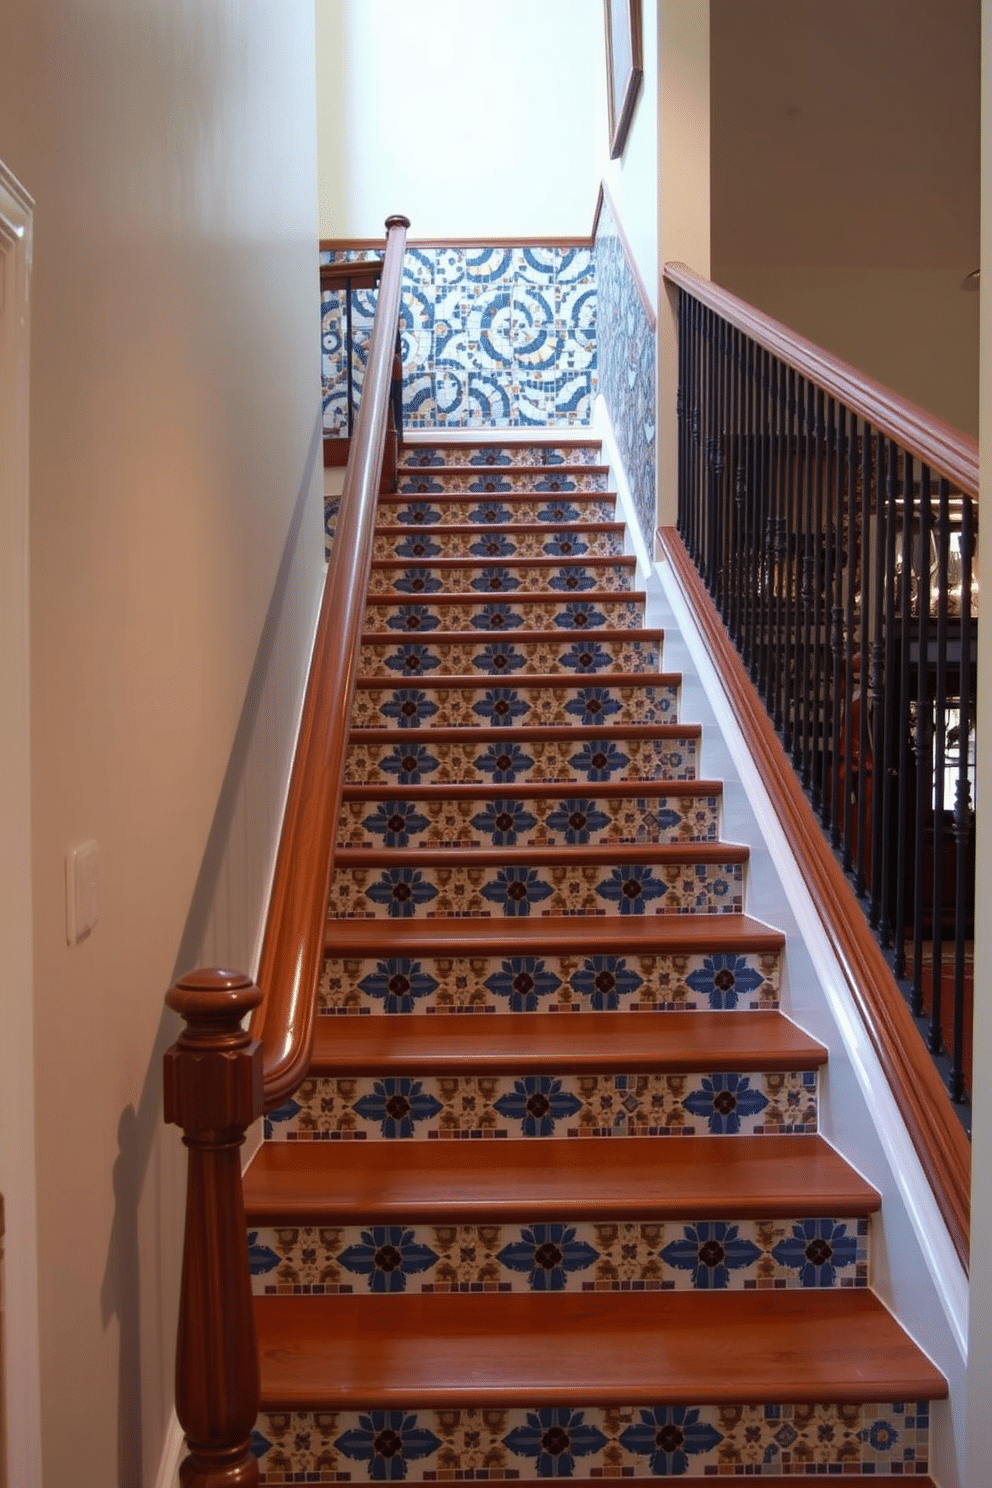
[164,217,409,1488]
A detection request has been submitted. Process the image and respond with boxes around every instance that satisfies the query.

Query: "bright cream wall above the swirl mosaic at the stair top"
[317,0,607,240]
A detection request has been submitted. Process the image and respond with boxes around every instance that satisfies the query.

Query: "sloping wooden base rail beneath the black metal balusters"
[657,527,971,1268]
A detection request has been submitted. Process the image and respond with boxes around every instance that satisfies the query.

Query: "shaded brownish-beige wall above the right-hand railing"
[711,0,980,434]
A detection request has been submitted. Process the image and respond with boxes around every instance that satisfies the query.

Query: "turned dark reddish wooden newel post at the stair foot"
[164,970,263,1488]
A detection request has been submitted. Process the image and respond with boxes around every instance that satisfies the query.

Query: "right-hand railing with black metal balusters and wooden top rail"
[665,263,979,1267]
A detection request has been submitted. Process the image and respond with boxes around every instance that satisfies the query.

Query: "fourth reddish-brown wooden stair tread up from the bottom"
[324,915,785,952]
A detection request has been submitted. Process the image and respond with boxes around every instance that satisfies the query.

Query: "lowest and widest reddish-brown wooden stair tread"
[254,1287,947,1409]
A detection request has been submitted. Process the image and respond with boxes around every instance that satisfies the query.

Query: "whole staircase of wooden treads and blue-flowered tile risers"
[245,440,946,1485]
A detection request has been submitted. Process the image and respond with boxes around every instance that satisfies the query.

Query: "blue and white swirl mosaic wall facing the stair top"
[321,247,596,434]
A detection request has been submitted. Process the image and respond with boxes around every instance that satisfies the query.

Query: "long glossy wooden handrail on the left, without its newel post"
[251,217,409,1110]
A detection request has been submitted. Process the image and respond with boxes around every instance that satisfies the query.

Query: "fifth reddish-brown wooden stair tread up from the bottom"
[335,845,750,869]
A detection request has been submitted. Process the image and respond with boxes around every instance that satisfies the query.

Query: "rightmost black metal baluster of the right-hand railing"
[947,496,977,1101]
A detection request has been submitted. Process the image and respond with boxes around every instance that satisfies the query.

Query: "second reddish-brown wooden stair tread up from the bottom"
[244,1135,880,1225]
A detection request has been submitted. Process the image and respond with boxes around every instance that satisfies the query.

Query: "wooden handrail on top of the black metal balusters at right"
[663,255,979,497]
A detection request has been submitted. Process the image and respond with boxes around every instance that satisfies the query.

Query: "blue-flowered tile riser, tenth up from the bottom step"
[364,594,644,633]
